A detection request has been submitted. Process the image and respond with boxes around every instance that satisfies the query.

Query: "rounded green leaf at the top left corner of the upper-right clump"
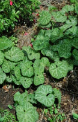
[39,10,51,25]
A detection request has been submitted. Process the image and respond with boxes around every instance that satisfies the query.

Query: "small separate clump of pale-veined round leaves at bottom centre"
[14,85,61,122]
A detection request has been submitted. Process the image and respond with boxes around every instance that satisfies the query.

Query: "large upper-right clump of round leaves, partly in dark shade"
[33,1,78,79]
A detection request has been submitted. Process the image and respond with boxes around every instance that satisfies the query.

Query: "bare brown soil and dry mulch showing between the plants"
[0,0,78,122]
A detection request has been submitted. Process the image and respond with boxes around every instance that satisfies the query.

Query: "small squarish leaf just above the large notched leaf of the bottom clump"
[34,73,44,86]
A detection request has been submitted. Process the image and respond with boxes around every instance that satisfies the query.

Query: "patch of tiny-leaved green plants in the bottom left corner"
[0,108,17,122]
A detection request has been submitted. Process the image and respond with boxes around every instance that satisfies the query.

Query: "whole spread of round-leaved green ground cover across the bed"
[0,0,78,122]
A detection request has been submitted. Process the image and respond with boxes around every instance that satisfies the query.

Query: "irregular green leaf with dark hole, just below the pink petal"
[22,46,40,60]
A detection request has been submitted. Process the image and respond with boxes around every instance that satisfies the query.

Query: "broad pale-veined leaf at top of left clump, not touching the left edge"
[5,47,24,62]
